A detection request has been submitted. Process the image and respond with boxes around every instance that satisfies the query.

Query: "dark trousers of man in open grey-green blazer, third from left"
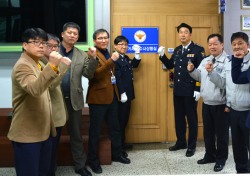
[64,98,86,170]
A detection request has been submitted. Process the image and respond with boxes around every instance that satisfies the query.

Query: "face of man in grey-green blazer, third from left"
[62,27,79,45]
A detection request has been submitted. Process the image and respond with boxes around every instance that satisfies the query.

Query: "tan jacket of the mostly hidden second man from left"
[40,57,69,127]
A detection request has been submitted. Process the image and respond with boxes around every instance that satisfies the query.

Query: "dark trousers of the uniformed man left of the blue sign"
[118,101,131,147]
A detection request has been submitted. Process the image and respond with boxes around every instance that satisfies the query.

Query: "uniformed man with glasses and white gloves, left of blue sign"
[114,35,141,150]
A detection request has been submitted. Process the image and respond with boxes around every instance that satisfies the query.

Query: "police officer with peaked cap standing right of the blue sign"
[158,23,205,157]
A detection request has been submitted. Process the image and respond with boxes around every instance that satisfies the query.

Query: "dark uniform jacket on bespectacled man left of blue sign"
[115,55,141,101]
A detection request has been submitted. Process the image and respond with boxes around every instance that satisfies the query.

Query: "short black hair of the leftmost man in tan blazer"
[22,28,48,42]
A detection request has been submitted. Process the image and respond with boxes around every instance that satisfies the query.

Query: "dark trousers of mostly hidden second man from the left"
[50,127,62,176]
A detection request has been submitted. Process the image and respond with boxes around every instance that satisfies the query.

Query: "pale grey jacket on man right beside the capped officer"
[190,51,227,105]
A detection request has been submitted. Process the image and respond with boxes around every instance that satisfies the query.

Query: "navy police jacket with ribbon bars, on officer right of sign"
[160,42,205,96]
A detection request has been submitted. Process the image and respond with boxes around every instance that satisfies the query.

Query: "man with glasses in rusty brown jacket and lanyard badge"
[87,29,130,174]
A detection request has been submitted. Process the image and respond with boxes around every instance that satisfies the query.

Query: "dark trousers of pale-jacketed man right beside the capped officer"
[202,103,229,164]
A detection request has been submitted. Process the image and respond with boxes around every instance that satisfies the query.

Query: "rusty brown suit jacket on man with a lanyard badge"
[87,49,119,104]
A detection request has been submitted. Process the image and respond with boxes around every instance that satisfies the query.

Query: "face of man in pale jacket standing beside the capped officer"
[208,37,224,57]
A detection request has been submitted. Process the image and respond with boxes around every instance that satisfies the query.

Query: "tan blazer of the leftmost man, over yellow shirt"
[8,53,58,143]
